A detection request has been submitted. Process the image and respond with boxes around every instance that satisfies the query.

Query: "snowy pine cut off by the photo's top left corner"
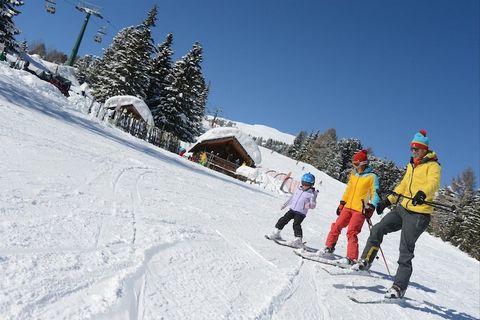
[0,0,23,52]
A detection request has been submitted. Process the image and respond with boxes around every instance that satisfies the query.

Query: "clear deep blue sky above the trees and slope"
[15,0,480,186]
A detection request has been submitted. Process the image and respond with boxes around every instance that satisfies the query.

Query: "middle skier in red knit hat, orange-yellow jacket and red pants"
[319,150,379,265]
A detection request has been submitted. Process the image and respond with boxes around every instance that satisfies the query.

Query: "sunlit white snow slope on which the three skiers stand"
[0,63,480,320]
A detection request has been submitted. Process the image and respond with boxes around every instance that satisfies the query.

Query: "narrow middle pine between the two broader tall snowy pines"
[146,33,173,117]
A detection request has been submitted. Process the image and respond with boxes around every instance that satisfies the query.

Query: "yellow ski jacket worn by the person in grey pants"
[388,151,442,214]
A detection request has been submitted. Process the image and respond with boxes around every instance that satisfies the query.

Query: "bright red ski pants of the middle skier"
[325,208,365,260]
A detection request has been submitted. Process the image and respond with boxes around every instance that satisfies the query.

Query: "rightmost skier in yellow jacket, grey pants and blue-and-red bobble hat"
[352,130,441,299]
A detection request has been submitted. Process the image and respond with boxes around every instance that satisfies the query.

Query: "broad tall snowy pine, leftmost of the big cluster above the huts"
[91,9,154,102]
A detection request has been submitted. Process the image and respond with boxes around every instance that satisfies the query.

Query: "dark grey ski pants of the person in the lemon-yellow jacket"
[362,205,431,290]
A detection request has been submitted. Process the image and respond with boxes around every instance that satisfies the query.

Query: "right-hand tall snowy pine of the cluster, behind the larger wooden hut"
[157,42,208,142]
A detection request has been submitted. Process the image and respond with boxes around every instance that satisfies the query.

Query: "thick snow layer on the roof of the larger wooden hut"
[197,127,262,164]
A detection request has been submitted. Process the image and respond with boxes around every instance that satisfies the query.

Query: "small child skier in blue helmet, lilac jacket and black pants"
[268,173,318,248]
